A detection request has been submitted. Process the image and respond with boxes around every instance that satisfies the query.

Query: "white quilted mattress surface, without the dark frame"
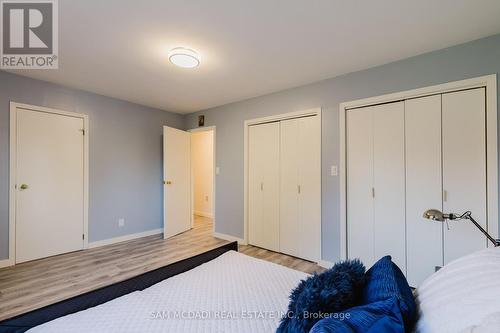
[29,251,307,333]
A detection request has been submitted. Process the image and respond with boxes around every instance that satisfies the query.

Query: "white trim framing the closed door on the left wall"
[9,102,89,266]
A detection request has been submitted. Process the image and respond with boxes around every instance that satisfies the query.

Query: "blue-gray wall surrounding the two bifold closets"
[186,35,500,261]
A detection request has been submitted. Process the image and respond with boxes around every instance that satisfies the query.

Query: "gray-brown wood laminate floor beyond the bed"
[0,217,324,320]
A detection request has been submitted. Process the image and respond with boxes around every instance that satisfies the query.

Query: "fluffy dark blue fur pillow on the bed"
[276,259,365,333]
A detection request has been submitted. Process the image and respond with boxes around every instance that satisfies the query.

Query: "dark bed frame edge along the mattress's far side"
[0,242,238,333]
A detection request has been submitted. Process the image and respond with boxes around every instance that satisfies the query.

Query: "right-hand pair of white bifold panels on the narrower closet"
[280,116,321,261]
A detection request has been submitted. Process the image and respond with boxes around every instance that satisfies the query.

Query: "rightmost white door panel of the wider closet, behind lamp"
[442,88,487,264]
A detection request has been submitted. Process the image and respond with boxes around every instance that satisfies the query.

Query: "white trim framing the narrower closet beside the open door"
[243,107,323,252]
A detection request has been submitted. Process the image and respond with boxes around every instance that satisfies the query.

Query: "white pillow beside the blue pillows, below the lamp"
[416,248,500,333]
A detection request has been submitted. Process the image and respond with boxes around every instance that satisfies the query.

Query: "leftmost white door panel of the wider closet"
[346,107,375,267]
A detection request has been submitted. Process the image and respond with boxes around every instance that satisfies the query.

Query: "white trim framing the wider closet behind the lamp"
[339,74,498,259]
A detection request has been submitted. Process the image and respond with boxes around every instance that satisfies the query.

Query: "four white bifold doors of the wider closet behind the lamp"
[346,88,488,286]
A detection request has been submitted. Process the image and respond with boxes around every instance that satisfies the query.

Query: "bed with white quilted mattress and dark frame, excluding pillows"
[0,244,308,333]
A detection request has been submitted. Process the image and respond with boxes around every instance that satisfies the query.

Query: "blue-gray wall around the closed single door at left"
[0,72,184,260]
